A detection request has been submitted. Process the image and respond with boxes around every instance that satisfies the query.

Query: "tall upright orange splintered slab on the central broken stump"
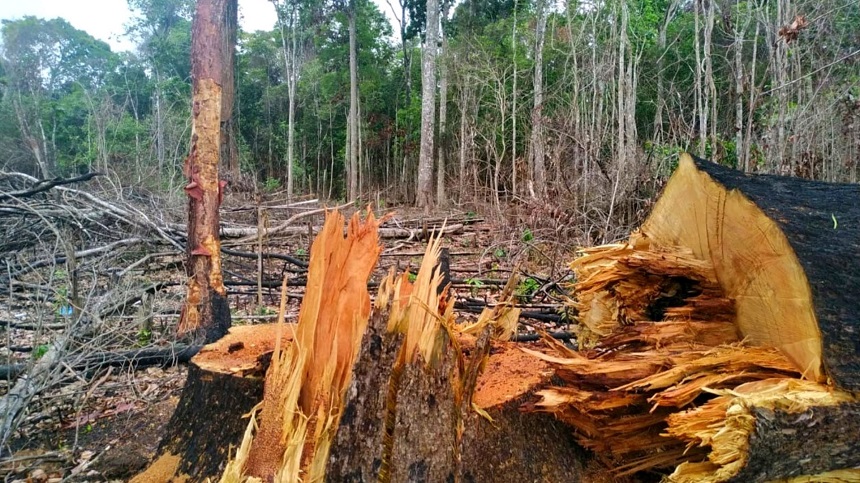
[221,210,380,482]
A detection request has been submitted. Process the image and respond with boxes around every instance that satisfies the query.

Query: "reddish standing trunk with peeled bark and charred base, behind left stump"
[179,0,236,342]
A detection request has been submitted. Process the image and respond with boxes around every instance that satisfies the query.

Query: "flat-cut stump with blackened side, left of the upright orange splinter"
[132,324,292,483]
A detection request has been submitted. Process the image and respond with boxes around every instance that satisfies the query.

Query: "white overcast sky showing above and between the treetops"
[0,0,398,52]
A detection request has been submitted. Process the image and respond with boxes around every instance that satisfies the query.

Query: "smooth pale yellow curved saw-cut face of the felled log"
[641,154,824,380]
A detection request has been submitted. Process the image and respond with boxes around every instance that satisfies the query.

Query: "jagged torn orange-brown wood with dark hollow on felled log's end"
[523,233,800,474]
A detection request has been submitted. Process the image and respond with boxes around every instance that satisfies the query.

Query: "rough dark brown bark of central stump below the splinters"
[326,313,596,483]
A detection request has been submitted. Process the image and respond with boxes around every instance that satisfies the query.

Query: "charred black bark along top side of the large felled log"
[694,158,860,391]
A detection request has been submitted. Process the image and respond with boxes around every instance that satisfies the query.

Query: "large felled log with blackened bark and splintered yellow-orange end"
[526,155,860,482]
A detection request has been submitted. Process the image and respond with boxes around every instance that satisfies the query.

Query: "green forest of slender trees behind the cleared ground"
[0,0,860,238]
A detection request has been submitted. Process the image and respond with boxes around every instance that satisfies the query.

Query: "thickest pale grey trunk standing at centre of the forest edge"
[416,0,439,209]
